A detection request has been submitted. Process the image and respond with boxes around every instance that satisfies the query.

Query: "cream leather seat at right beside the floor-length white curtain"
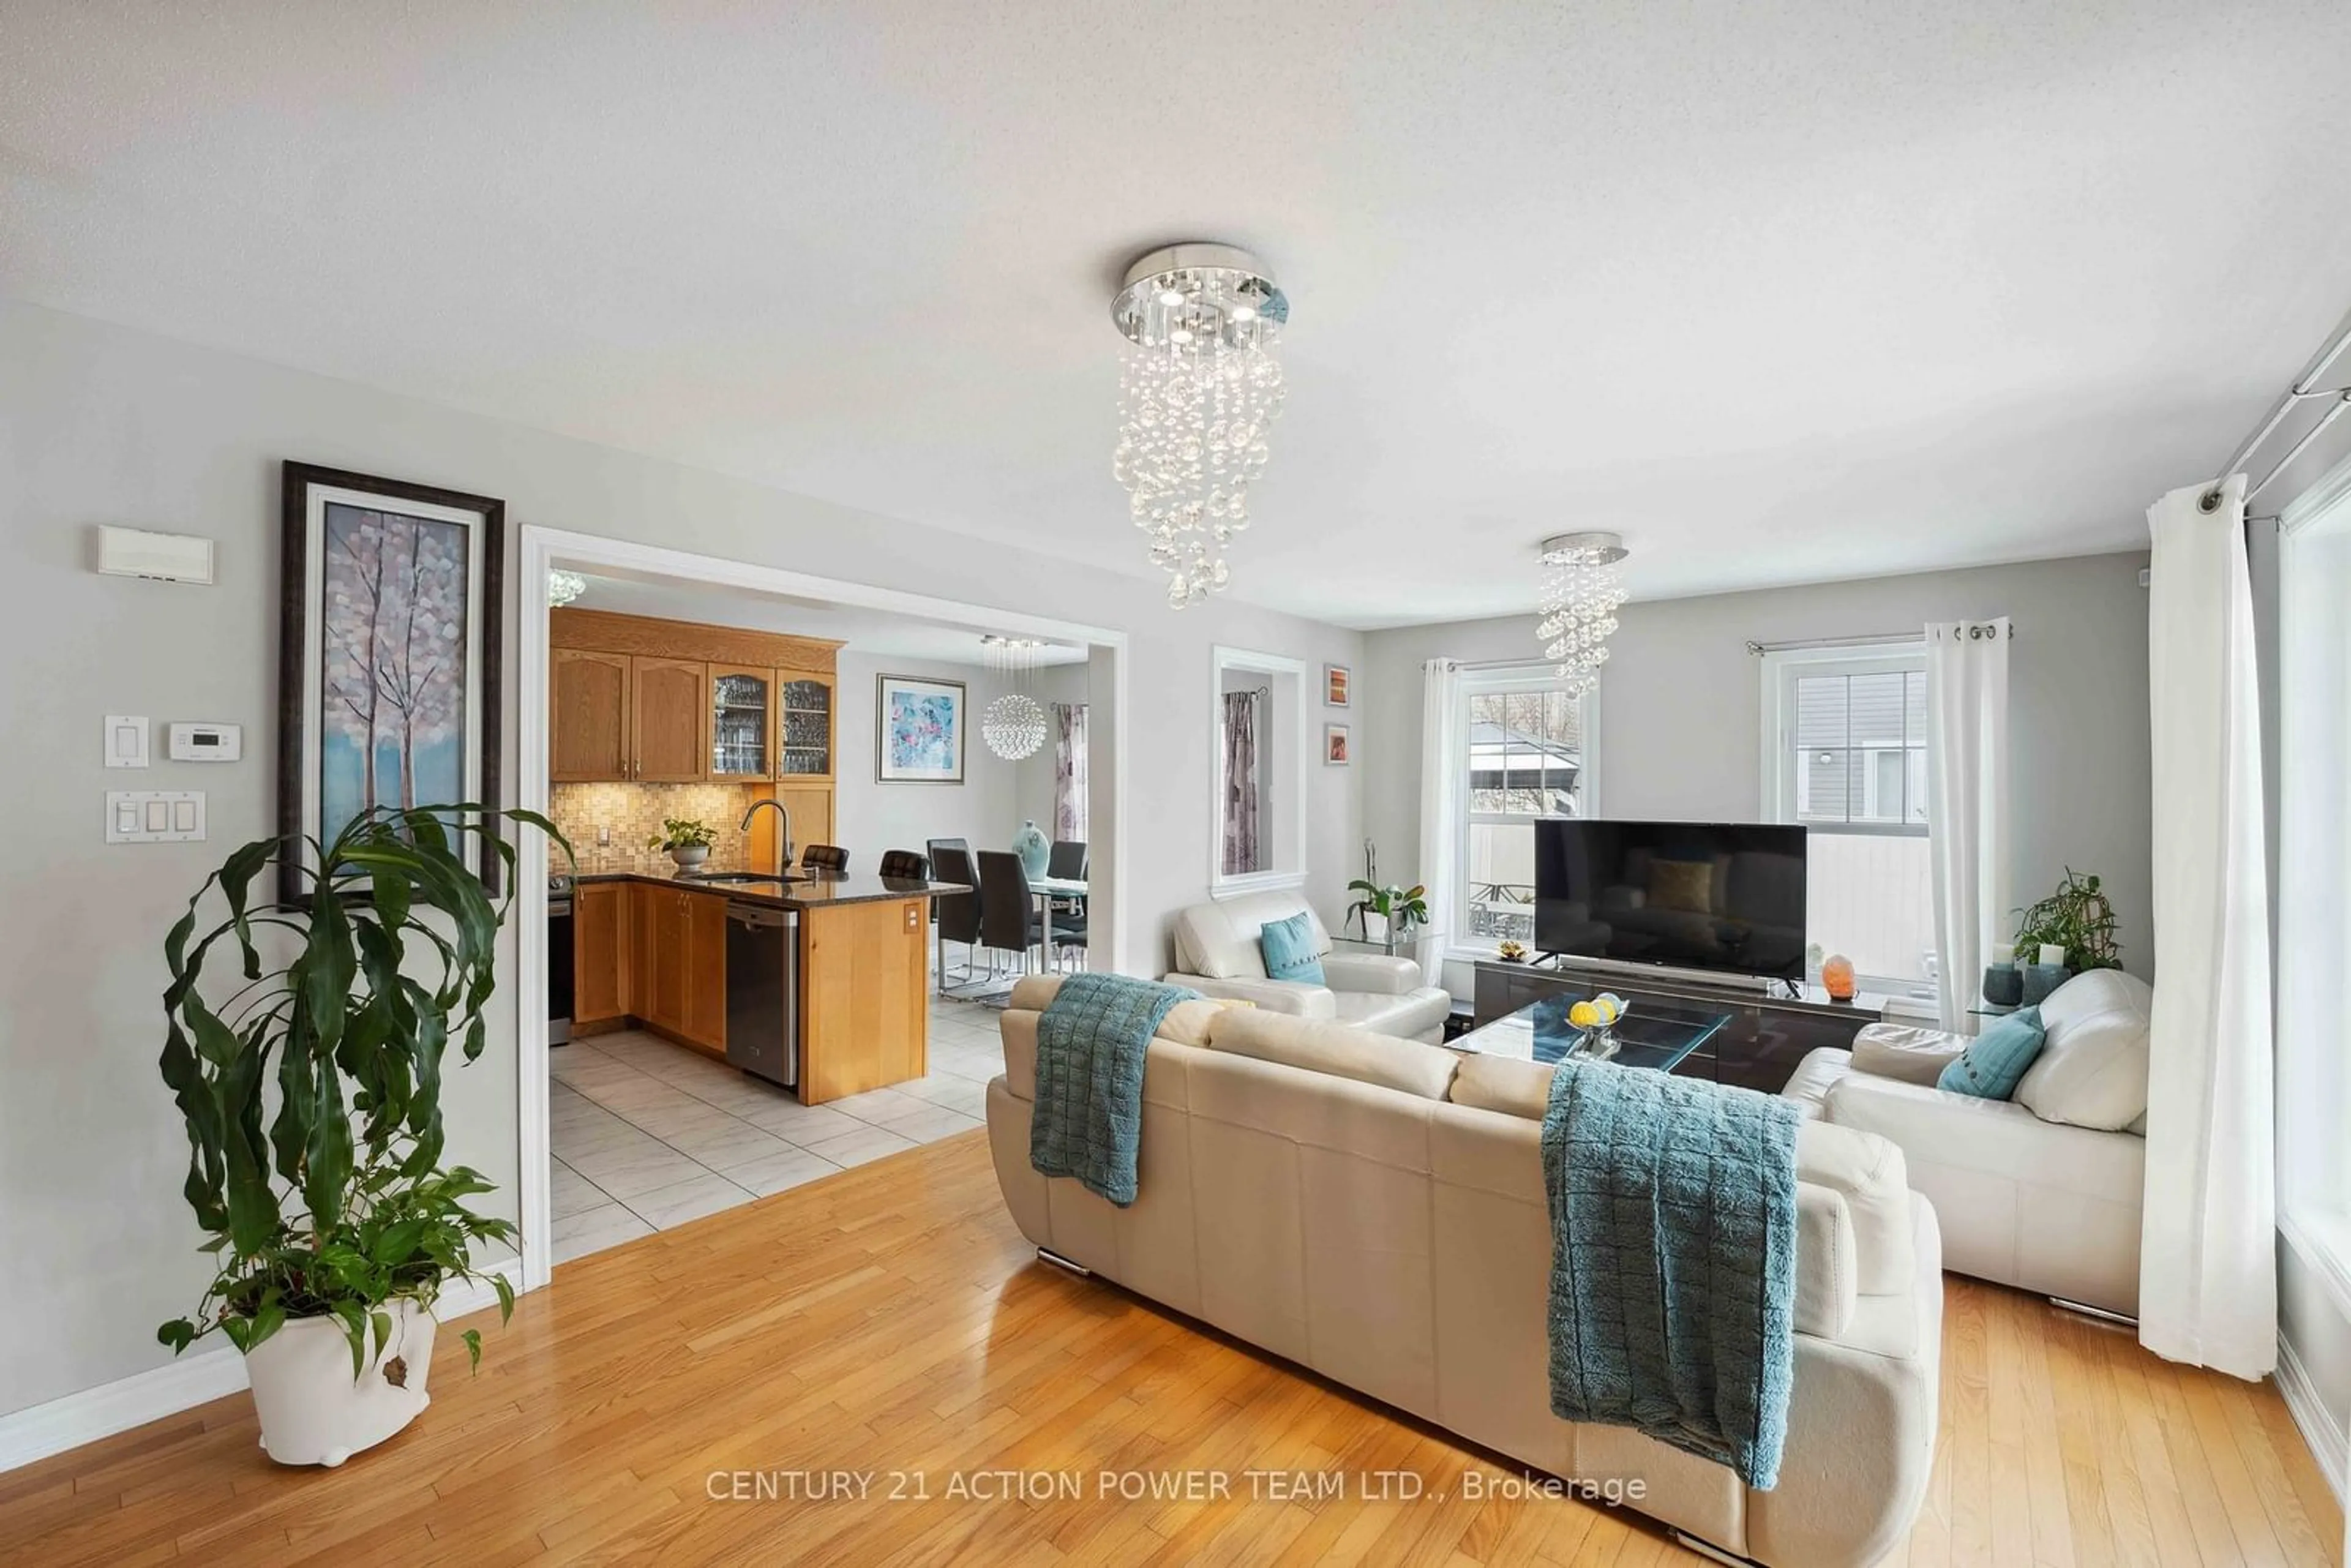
[1780,969,2153,1316]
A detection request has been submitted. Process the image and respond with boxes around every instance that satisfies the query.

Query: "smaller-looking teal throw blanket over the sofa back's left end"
[1030,973,1199,1209]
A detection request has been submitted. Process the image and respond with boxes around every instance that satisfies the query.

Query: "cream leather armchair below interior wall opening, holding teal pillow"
[1166,893,1453,1044]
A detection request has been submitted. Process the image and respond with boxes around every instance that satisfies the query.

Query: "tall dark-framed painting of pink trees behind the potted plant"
[277,463,506,902]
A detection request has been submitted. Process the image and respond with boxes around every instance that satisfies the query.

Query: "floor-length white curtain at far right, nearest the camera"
[2139,475,2278,1378]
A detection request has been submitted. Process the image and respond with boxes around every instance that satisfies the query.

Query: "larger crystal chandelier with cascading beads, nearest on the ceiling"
[1109,244,1291,609]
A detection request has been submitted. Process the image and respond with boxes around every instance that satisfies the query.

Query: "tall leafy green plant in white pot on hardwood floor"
[155,806,571,1465]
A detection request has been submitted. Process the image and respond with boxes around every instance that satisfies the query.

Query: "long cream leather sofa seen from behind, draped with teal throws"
[988,975,1942,1568]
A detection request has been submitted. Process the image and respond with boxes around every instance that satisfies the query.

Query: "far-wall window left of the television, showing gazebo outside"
[1453,667,1592,947]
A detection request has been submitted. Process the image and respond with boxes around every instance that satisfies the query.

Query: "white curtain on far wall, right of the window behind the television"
[1925,616,2015,1034]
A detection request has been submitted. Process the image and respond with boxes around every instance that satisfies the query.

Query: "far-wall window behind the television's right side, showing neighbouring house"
[1763,644,1935,994]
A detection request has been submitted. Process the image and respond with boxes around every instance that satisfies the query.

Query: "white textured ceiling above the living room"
[0,0,2351,625]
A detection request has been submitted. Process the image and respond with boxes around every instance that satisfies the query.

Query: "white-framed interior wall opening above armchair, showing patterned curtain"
[1209,649,1312,893]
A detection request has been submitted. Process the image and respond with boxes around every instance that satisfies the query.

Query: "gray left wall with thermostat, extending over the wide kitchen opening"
[0,303,1363,1413]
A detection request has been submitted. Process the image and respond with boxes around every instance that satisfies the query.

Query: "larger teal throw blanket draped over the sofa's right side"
[1542,1060,1799,1490]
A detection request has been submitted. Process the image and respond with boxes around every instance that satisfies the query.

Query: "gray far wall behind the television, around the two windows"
[1357,552,2153,975]
